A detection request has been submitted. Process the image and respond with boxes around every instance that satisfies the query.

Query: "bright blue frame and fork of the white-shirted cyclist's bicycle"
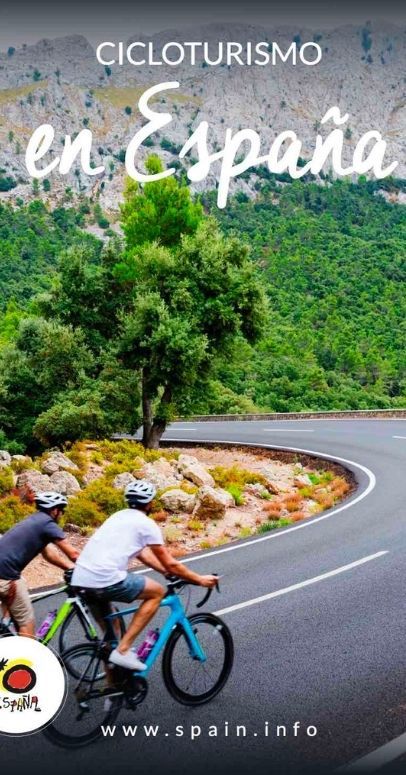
[105,593,206,678]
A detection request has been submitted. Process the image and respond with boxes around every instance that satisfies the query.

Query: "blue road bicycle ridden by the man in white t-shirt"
[44,579,234,748]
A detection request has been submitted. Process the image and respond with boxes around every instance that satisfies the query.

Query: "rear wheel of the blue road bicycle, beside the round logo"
[44,643,123,748]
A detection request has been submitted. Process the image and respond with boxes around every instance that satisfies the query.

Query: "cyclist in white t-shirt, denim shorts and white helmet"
[71,479,217,670]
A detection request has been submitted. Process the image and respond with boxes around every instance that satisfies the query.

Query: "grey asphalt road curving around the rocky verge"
[0,420,406,775]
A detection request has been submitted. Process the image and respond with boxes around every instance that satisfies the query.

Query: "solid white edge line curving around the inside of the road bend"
[159,439,376,573]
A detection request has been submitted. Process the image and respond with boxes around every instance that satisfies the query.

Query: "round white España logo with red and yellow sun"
[0,636,66,735]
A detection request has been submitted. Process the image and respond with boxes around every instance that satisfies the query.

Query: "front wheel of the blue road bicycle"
[162,613,234,705]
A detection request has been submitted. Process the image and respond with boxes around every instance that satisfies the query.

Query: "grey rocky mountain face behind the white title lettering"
[0,23,406,210]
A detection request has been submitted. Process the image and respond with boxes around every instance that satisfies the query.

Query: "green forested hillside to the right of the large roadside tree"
[208,181,406,411]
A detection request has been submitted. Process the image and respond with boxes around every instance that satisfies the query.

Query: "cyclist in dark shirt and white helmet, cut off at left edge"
[0,492,79,638]
